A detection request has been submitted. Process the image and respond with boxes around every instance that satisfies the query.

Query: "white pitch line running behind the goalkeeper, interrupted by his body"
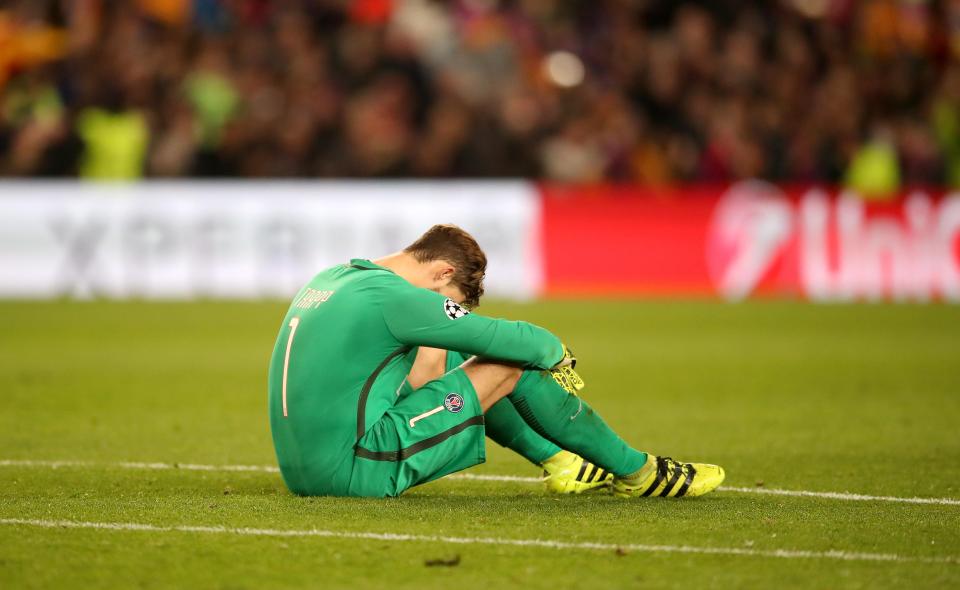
[0,459,960,506]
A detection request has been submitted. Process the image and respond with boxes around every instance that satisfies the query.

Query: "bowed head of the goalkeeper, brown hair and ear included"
[403,224,487,307]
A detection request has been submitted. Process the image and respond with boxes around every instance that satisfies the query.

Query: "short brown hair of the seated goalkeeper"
[403,224,487,307]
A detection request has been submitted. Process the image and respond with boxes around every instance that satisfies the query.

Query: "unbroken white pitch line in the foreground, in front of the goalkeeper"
[0,518,960,564]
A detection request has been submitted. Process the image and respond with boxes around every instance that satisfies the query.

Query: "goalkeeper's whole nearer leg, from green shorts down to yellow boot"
[351,358,723,496]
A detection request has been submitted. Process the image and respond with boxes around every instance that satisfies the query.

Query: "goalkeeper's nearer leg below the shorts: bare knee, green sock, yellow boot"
[463,359,724,497]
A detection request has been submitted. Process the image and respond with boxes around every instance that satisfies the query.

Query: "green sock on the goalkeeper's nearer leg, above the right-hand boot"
[507,370,647,475]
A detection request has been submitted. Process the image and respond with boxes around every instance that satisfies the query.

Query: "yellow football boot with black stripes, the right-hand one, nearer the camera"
[612,455,726,498]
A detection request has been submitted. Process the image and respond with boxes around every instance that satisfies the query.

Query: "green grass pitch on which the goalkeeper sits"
[0,301,960,589]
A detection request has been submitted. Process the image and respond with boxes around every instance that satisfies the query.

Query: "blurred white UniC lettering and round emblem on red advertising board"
[706,181,960,301]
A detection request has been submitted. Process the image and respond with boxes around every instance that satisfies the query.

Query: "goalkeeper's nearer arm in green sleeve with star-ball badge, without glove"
[382,287,564,369]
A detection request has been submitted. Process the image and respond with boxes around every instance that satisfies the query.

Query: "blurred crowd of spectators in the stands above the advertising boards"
[0,0,960,195]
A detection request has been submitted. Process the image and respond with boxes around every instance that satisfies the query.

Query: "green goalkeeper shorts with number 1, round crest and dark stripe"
[349,368,486,497]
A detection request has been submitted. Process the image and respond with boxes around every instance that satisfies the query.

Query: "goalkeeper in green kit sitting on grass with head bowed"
[269,225,724,497]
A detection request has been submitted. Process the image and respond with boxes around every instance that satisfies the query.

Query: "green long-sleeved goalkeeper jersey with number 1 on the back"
[268,259,563,491]
